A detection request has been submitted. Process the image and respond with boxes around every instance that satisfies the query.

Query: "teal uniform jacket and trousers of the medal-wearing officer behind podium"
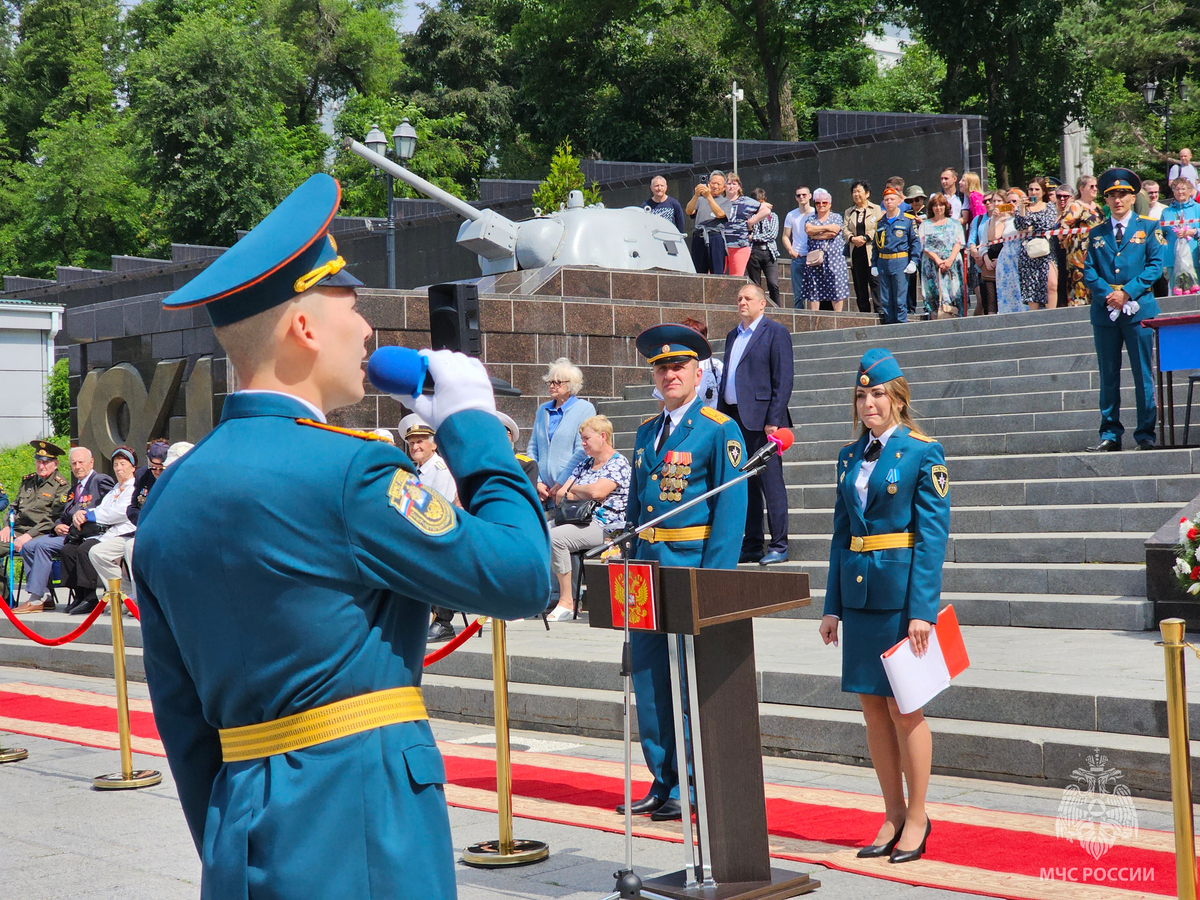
[625,397,746,800]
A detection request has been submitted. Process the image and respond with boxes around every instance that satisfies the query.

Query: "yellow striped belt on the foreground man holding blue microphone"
[220,688,430,762]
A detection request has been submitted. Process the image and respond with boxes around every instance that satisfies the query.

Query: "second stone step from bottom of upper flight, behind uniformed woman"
[744,554,1146,596]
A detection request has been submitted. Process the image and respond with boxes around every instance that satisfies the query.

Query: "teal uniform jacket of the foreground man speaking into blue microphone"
[134,394,550,900]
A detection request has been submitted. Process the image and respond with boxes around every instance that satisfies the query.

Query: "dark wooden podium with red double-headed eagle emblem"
[588,560,821,900]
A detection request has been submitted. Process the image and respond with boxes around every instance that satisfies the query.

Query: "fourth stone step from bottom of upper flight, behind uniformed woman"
[787,502,1180,540]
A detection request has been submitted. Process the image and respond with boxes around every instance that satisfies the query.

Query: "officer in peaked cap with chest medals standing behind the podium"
[618,325,746,821]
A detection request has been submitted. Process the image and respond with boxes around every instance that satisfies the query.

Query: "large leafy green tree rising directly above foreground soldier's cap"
[128,10,329,245]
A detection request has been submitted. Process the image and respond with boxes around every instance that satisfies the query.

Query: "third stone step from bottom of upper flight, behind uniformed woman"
[787,532,1150,565]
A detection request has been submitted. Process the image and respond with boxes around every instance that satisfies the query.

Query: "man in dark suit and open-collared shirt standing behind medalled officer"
[716,284,794,565]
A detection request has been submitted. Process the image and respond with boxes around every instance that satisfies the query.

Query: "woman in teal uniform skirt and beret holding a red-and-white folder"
[821,349,950,863]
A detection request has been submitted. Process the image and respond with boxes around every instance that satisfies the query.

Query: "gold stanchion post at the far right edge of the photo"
[1158,619,1196,900]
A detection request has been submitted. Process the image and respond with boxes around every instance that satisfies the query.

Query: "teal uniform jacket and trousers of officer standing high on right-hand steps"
[1084,215,1168,445]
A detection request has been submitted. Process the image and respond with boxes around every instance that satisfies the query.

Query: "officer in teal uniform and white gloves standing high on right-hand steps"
[1084,169,1166,452]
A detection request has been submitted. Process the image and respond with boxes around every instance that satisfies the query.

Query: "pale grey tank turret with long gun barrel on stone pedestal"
[344,138,696,275]
